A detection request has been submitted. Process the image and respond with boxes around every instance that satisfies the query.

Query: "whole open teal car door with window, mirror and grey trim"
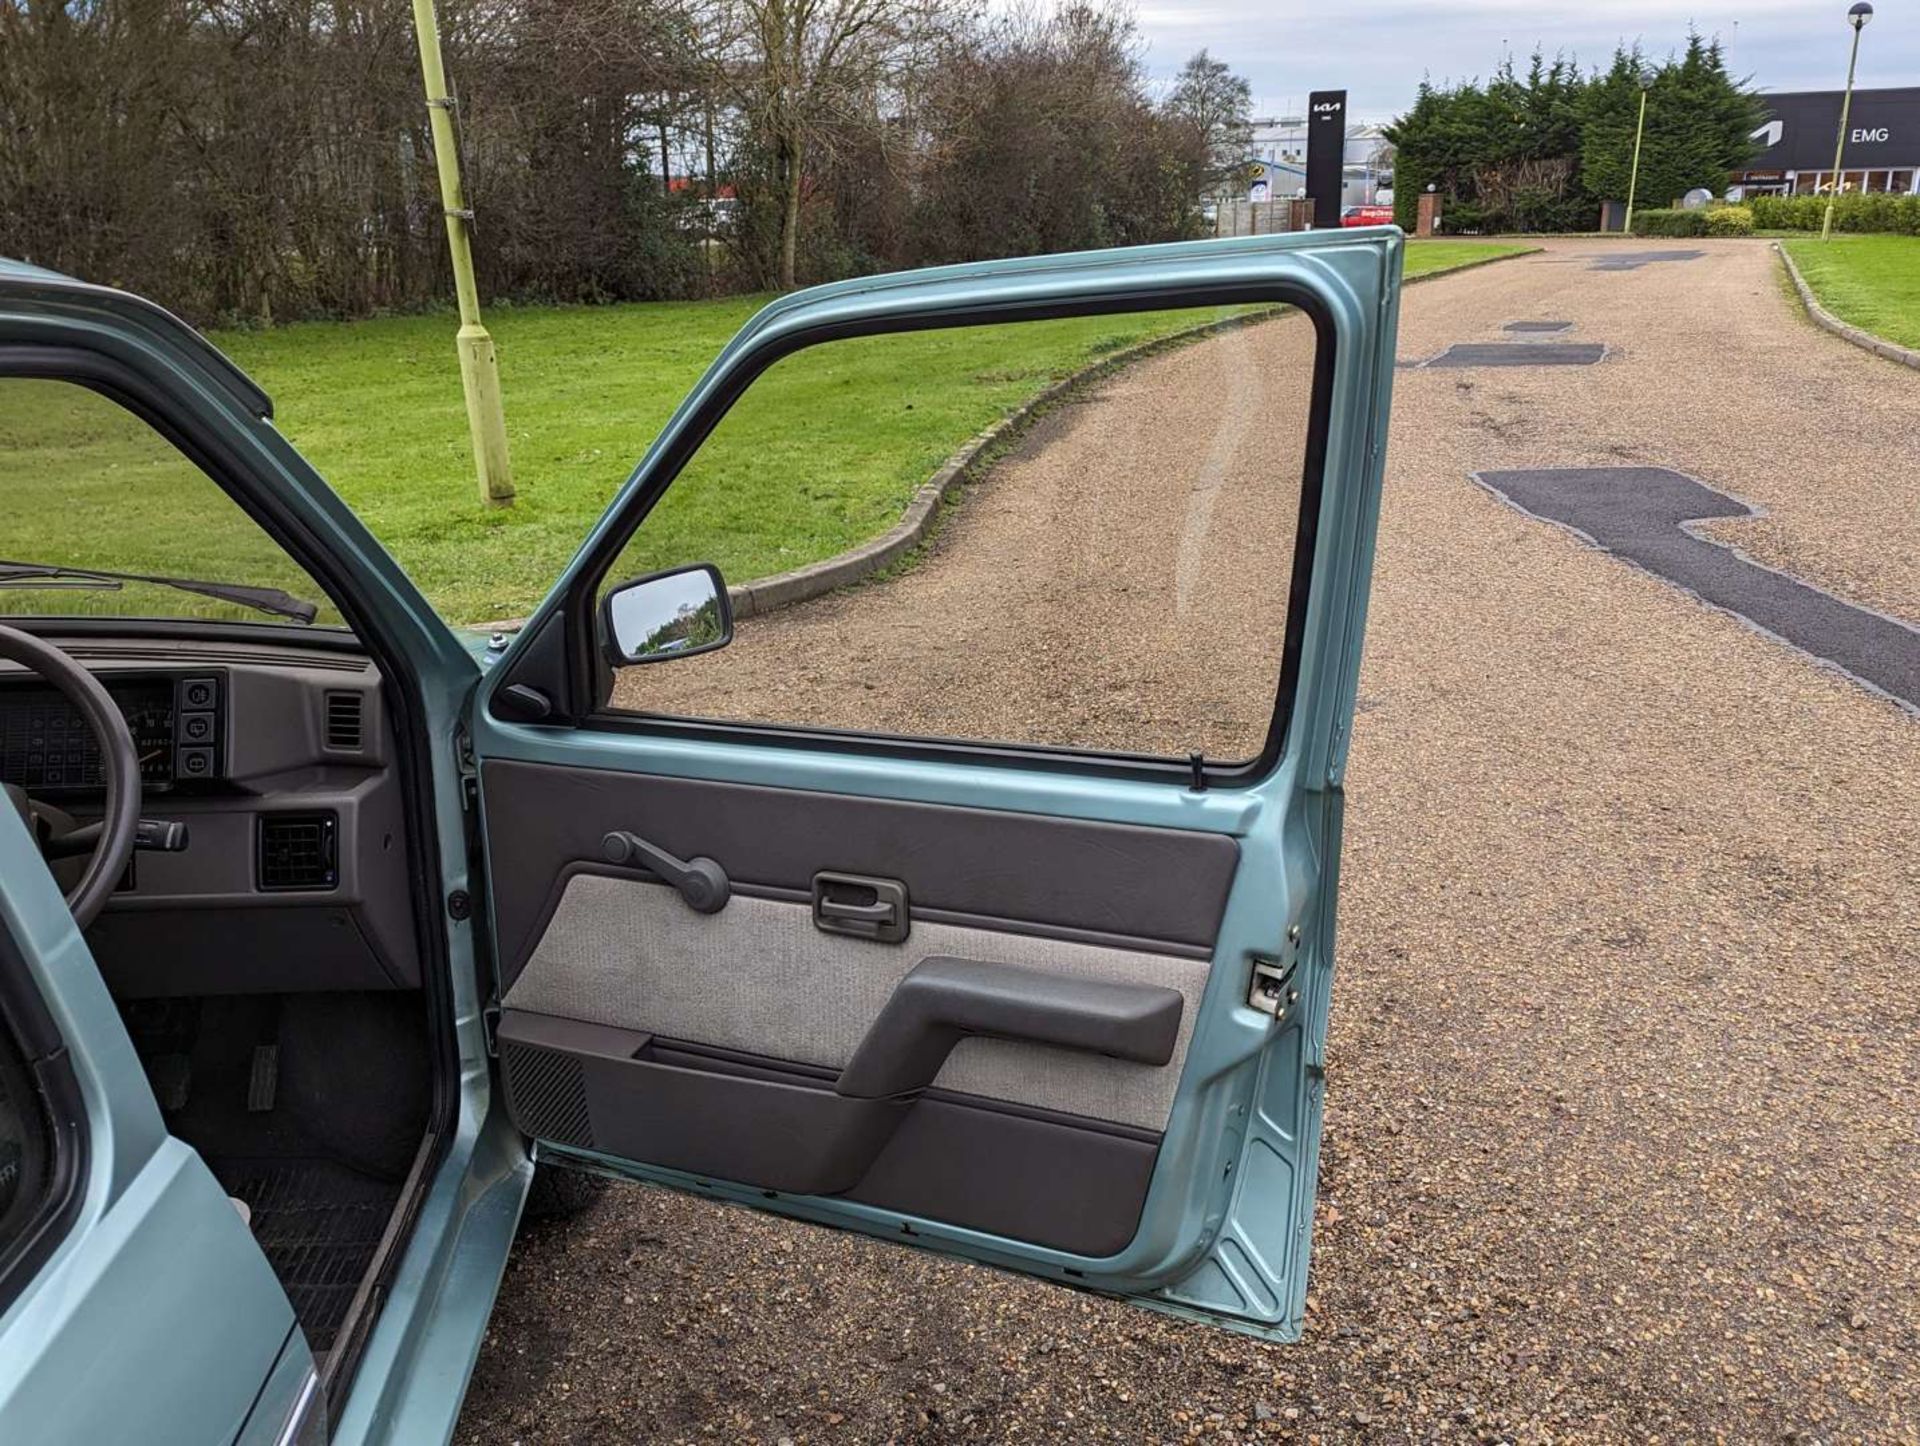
[472,229,1402,1338]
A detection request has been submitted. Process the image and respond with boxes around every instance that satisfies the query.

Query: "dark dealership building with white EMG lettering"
[1734,86,1920,196]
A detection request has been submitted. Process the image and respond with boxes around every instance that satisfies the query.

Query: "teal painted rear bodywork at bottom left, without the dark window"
[0,808,299,1446]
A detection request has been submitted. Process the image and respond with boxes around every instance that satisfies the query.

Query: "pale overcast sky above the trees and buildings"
[1137,0,1920,119]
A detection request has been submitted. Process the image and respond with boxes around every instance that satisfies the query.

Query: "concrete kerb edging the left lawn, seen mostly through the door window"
[487,246,1540,632]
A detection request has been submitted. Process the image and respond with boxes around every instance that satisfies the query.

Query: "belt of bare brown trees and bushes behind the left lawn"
[0,0,1196,323]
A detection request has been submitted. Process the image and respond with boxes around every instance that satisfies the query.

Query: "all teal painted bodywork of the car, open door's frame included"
[0,216,1402,1446]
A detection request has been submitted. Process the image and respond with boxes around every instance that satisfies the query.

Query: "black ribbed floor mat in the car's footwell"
[209,1160,399,1352]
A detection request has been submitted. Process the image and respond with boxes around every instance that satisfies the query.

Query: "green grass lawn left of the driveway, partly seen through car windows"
[0,242,1528,622]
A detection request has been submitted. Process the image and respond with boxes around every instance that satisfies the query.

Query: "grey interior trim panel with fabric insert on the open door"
[482,760,1238,1256]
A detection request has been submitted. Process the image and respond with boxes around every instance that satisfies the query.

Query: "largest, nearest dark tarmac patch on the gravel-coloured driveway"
[1473,467,1920,712]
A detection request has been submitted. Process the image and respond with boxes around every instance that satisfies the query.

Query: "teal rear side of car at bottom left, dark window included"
[0,803,326,1446]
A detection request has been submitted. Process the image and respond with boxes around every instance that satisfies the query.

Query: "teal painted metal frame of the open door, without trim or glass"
[474,229,1402,1338]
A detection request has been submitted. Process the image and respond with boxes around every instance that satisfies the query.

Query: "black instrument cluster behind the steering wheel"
[0,672,227,797]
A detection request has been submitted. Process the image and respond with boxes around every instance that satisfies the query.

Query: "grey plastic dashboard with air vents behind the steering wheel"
[0,634,420,999]
